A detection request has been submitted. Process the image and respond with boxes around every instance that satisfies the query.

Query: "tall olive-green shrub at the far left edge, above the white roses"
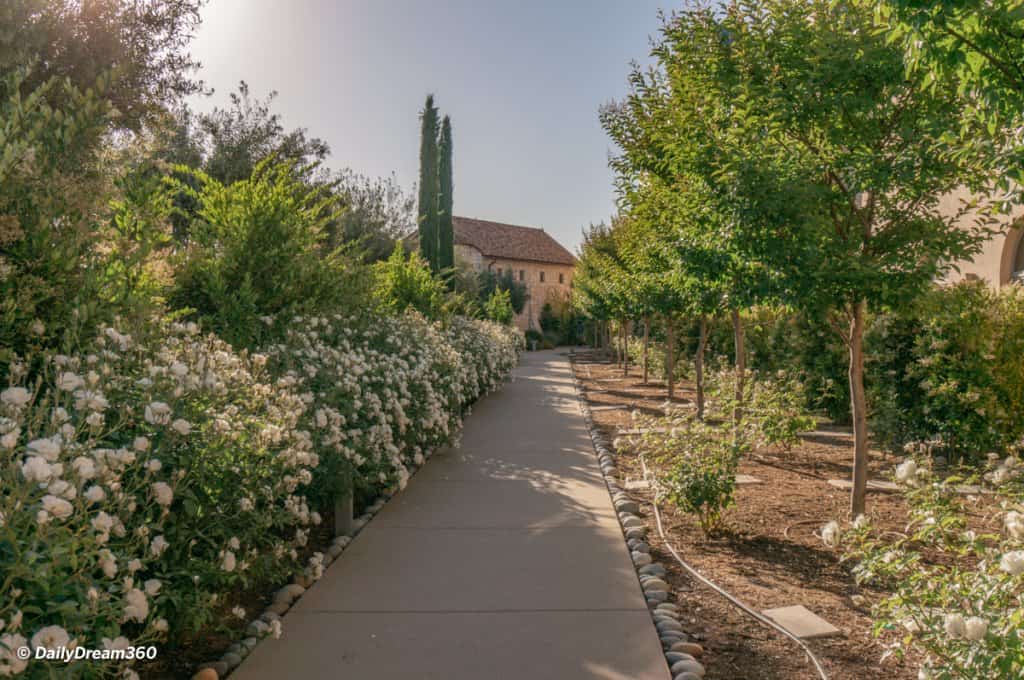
[0,70,119,380]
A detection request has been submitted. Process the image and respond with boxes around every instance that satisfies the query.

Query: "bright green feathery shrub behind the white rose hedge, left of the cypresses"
[170,160,368,348]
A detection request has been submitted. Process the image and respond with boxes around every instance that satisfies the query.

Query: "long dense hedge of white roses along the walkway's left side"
[0,314,521,677]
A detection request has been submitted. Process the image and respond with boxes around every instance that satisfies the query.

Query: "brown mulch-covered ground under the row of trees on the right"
[574,351,919,680]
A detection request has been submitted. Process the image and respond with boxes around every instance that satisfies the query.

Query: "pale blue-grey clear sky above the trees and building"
[191,0,679,251]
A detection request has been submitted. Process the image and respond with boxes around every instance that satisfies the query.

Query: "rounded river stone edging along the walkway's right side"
[569,354,705,680]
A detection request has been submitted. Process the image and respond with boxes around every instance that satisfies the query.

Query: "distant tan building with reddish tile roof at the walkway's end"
[453,217,575,331]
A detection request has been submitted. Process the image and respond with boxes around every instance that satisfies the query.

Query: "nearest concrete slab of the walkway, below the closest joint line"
[231,611,669,680]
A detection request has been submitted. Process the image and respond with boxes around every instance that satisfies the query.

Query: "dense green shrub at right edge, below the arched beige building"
[868,283,1024,460]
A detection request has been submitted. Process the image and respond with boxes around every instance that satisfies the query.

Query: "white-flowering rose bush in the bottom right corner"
[822,442,1024,680]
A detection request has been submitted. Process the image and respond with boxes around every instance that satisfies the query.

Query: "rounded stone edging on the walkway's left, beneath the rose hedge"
[193,450,434,680]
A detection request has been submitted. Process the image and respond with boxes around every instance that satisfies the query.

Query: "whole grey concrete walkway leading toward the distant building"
[231,351,670,680]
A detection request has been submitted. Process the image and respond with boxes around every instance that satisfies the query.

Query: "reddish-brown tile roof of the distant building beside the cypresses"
[452,217,575,265]
